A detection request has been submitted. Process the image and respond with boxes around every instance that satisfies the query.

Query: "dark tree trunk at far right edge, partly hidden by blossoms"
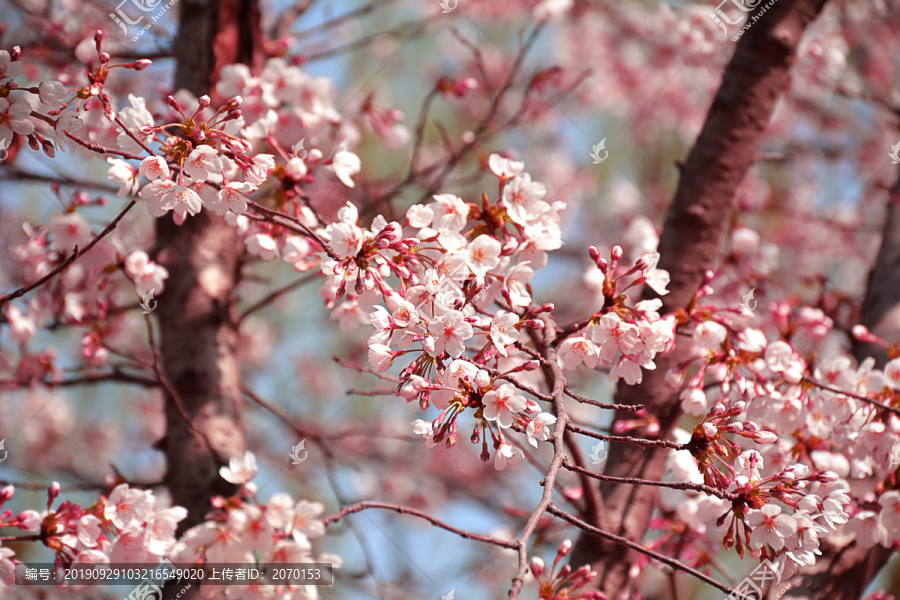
[770,170,900,600]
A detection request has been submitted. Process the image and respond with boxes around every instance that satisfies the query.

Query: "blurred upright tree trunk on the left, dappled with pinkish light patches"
[156,0,261,531]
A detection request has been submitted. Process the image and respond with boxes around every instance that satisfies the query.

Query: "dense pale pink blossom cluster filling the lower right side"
[662,290,900,573]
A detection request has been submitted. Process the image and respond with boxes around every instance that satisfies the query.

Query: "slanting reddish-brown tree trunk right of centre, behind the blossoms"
[570,0,826,598]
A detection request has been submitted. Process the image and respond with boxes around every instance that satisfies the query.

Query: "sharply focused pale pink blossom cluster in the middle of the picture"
[308,154,674,470]
